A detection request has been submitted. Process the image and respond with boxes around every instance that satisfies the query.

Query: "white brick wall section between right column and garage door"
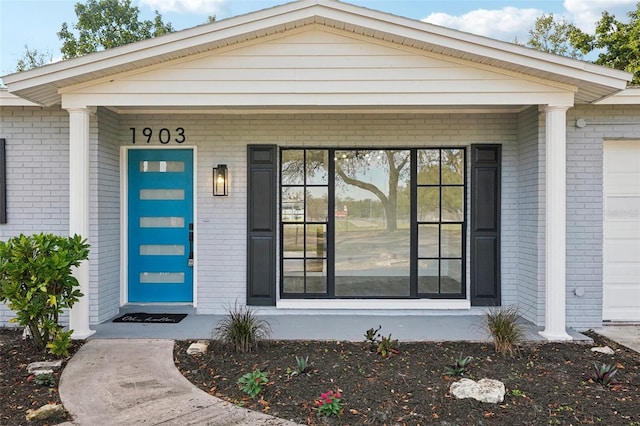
[567,105,640,329]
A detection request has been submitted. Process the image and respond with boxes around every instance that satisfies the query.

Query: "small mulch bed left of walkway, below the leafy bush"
[0,327,83,426]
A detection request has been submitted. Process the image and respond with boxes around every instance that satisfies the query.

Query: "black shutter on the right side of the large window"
[471,145,502,306]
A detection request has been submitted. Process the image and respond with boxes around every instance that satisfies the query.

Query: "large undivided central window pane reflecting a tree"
[335,150,410,297]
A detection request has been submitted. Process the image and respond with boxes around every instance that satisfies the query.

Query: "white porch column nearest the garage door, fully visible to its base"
[540,106,571,340]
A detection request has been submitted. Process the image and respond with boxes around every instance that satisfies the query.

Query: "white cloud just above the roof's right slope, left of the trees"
[423,7,543,42]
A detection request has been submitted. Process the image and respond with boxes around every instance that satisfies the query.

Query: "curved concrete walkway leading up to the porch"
[59,339,295,426]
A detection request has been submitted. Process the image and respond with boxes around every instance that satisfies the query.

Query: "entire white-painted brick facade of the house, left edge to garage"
[5,106,640,328]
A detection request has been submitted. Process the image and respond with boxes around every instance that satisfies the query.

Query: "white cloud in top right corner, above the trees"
[564,0,637,33]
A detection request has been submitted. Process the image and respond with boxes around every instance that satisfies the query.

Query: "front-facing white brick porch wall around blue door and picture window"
[120,114,518,313]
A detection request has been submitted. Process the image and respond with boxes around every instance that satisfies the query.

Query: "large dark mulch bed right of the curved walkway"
[174,333,640,426]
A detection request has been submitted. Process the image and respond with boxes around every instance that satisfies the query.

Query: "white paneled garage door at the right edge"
[602,140,640,321]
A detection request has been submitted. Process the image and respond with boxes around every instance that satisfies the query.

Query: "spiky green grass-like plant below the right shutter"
[484,307,524,356]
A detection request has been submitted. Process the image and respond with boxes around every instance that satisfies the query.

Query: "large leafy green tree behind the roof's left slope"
[58,0,173,59]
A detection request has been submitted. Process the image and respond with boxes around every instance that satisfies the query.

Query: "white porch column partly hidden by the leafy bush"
[67,108,95,339]
